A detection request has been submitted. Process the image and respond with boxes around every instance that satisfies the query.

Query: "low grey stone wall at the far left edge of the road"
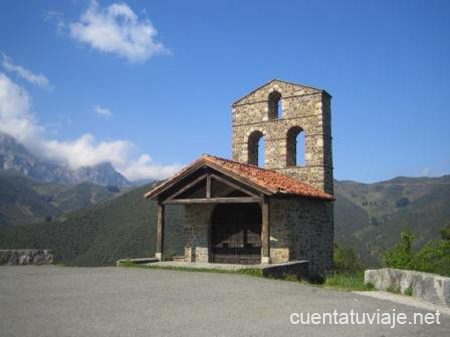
[0,249,53,265]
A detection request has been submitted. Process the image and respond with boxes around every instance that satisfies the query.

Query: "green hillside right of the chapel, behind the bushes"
[335,176,450,263]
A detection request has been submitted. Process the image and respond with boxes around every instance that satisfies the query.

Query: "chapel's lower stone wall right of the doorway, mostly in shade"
[270,198,334,276]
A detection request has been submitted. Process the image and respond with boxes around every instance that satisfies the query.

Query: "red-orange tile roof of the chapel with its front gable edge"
[145,155,334,201]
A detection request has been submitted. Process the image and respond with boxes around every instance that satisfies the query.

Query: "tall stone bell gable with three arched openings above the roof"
[232,80,333,194]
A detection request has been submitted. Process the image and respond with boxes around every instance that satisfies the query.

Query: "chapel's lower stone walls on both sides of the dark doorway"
[185,198,333,275]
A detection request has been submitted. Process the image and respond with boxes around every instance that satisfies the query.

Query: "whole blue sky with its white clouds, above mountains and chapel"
[0,0,450,182]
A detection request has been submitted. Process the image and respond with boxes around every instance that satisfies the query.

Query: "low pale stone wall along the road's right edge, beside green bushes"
[364,268,450,306]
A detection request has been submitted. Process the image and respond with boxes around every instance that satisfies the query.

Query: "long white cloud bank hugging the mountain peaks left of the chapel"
[0,73,181,180]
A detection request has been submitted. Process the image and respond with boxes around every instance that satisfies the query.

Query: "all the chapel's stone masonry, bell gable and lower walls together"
[176,80,334,276]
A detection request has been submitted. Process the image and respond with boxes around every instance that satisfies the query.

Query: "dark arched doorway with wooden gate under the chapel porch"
[211,203,261,264]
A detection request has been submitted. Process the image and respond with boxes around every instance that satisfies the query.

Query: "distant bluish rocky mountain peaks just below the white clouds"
[0,132,132,187]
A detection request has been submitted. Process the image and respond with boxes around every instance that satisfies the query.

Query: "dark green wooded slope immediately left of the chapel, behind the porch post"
[0,181,184,266]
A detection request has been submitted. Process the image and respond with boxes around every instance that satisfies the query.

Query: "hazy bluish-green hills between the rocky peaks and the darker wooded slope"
[0,171,121,227]
